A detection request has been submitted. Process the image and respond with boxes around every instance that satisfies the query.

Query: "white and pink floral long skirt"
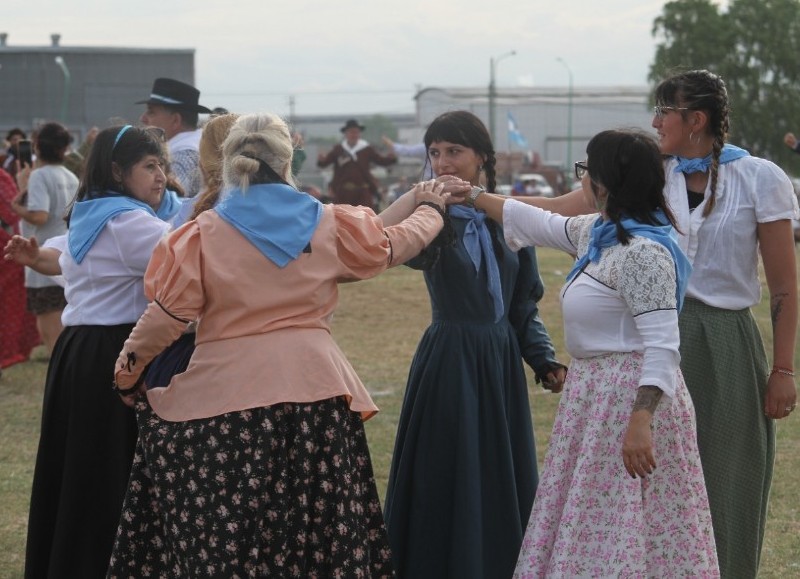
[514,354,719,578]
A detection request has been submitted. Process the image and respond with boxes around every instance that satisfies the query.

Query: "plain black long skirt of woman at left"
[25,324,137,579]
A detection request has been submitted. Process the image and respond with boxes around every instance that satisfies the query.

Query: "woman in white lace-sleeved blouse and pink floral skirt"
[466,131,718,578]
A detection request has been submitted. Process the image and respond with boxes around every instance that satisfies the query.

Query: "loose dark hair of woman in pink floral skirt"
[586,129,677,244]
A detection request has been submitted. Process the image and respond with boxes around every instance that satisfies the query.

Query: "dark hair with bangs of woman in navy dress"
[423,111,497,192]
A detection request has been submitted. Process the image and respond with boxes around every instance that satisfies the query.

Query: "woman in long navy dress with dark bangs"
[382,111,564,578]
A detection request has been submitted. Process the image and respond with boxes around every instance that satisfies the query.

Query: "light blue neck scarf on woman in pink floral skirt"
[567,210,692,312]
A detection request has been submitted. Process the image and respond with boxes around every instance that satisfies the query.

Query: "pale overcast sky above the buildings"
[7,0,732,115]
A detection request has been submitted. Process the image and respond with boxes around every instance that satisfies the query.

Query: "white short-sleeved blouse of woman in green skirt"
[664,157,800,310]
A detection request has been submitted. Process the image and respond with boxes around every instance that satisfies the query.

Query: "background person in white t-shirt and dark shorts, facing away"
[12,123,78,354]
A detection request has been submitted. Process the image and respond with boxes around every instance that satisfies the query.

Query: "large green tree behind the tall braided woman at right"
[648,0,800,173]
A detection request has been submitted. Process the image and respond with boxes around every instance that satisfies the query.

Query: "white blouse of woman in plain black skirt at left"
[54,210,169,326]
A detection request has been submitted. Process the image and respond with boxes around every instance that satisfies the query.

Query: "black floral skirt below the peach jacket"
[109,398,394,578]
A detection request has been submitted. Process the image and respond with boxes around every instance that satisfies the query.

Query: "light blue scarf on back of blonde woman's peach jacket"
[214,183,322,267]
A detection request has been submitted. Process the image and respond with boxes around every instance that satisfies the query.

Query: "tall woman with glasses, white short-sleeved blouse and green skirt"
[653,70,798,577]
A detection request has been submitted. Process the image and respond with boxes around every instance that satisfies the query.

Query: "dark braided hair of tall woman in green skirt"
[655,70,730,217]
